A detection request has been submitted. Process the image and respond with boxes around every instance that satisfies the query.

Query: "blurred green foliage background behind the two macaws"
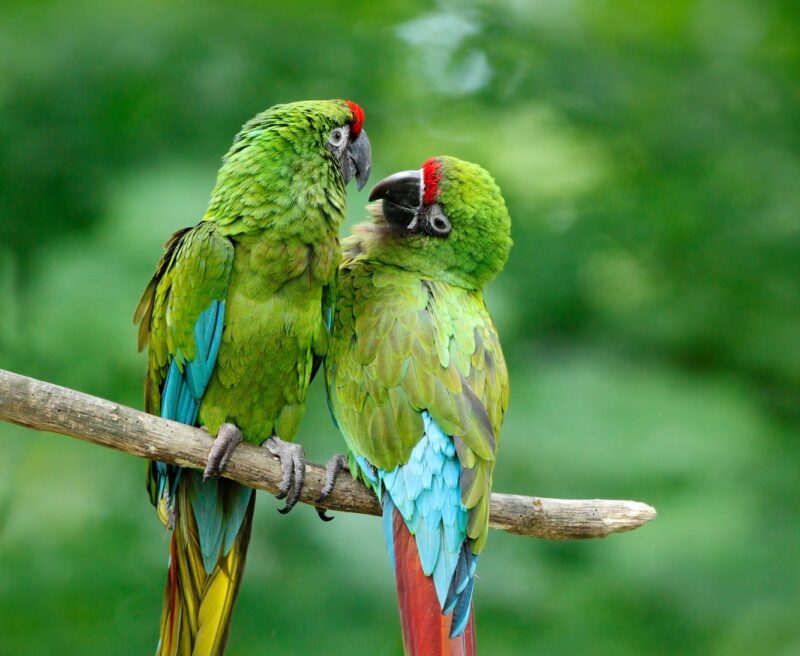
[0,0,800,656]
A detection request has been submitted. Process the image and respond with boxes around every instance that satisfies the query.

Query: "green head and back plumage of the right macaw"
[326,158,511,554]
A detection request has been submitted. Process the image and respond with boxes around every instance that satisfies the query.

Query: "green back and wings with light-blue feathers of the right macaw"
[327,257,508,636]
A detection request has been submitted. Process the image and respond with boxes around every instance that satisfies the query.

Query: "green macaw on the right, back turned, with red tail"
[325,157,511,656]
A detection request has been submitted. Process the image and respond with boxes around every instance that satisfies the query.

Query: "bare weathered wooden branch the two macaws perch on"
[0,369,656,540]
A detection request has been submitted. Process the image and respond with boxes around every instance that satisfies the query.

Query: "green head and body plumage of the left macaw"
[137,101,352,443]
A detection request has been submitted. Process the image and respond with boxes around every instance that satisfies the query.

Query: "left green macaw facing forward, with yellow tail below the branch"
[134,100,371,656]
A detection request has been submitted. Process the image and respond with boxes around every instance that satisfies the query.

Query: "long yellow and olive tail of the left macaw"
[157,472,255,656]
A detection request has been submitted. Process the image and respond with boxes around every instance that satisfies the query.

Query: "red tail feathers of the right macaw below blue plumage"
[392,509,477,656]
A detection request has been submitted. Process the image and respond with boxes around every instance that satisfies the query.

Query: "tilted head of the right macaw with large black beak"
[369,156,511,289]
